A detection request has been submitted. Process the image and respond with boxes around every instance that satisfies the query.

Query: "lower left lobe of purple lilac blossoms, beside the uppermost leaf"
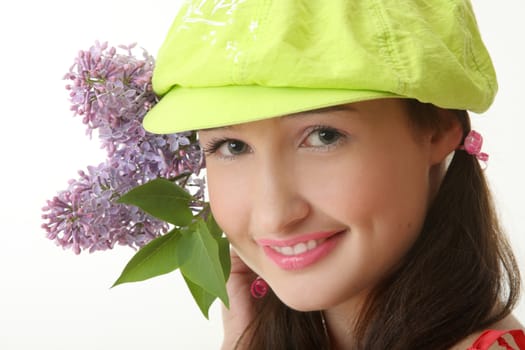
[43,163,168,254]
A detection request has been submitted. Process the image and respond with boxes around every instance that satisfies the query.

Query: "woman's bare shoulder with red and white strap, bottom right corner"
[450,315,525,350]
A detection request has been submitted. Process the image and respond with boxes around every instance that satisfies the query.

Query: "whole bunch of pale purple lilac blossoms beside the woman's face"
[42,42,204,254]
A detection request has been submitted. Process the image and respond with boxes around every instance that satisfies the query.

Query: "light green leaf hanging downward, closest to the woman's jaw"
[177,219,229,306]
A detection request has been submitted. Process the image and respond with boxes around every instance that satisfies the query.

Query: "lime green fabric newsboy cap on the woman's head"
[144,0,497,133]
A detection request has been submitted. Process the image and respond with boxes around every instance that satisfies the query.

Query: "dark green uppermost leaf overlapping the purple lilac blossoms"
[118,178,193,226]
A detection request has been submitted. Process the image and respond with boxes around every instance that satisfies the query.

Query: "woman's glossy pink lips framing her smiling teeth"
[257,231,345,270]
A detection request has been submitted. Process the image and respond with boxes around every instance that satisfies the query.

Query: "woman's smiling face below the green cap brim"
[199,99,450,311]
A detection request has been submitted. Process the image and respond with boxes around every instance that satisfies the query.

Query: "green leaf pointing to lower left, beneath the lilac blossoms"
[112,230,183,287]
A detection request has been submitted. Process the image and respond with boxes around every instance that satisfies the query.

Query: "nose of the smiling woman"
[251,159,311,234]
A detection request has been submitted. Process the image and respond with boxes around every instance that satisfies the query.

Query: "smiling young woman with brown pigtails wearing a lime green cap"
[144,0,525,349]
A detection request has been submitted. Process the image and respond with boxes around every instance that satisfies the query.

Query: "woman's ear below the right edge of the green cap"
[430,109,463,164]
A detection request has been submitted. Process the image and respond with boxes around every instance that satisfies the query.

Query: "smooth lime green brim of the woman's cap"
[143,85,397,134]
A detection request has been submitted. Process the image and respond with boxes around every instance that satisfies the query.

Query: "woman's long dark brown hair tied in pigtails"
[234,100,520,350]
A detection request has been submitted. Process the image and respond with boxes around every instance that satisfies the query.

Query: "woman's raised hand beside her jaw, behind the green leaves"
[221,249,257,350]
